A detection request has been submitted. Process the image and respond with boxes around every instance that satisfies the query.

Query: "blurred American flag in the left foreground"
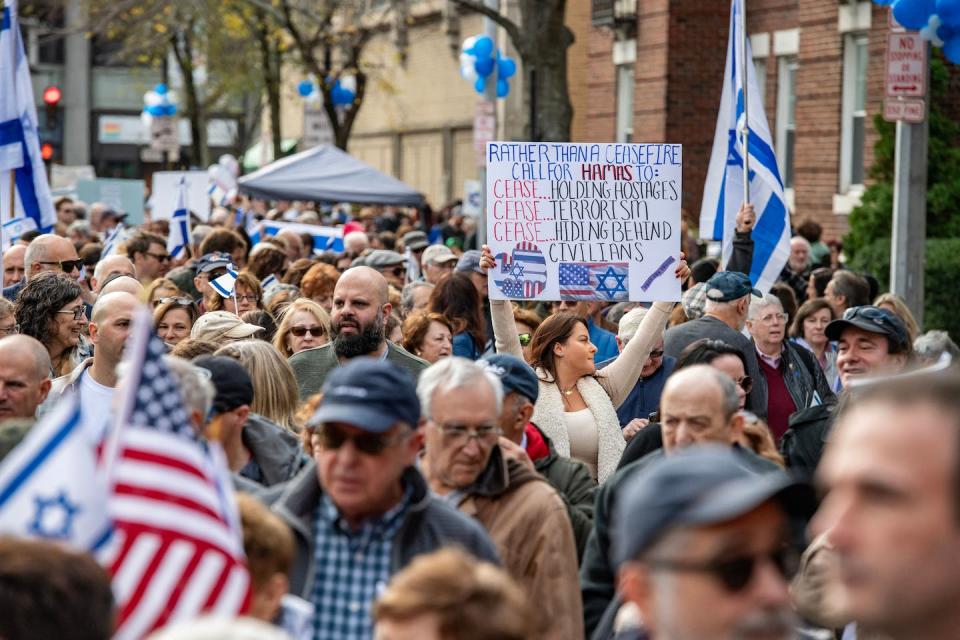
[100,311,250,640]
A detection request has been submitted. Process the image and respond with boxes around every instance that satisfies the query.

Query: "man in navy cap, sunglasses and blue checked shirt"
[273,358,497,640]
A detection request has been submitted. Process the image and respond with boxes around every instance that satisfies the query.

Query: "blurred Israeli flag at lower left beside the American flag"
[0,392,112,551]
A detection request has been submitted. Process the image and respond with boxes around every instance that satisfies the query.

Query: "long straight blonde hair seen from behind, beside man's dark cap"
[214,340,300,433]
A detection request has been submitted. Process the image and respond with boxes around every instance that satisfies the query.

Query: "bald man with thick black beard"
[290,267,429,399]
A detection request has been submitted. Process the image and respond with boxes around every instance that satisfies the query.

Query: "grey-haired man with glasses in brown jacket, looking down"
[417,357,583,638]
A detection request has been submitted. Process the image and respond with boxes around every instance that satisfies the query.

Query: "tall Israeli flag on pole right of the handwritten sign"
[700,0,790,292]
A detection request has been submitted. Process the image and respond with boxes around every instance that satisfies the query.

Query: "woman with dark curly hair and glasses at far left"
[14,271,91,378]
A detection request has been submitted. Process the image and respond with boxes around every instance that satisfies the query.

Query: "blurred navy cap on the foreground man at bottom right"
[611,445,816,566]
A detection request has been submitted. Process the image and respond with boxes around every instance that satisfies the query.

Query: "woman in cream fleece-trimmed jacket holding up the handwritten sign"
[480,246,690,483]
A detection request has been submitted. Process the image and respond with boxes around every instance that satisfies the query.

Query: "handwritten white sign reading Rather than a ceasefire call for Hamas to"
[487,142,683,302]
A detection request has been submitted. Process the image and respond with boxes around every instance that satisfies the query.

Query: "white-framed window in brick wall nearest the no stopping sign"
[840,34,868,193]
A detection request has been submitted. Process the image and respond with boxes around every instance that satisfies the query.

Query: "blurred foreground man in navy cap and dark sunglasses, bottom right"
[613,446,815,640]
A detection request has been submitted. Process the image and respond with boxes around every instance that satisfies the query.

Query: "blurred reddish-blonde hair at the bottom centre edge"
[373,548,540,640]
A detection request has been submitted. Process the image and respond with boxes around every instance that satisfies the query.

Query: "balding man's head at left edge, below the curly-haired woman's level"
[0,335,51,420]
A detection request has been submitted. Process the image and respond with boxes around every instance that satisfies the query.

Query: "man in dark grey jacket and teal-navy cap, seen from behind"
[663,271,767,418]
